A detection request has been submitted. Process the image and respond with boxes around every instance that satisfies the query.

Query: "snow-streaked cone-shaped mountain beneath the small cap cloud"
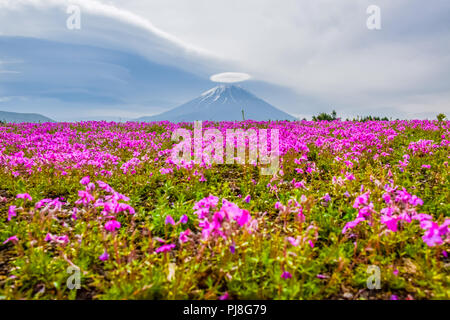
[137,85,296,122]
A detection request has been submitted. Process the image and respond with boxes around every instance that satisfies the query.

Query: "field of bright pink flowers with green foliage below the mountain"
[0,120,450,299]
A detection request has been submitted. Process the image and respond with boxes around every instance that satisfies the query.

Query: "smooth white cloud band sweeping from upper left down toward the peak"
[0,0,225,73]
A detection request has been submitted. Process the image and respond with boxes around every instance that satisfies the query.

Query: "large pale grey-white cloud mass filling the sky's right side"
[104,0,450,115]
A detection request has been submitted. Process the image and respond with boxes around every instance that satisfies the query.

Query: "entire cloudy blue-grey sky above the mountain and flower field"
[0,0,450,120]
